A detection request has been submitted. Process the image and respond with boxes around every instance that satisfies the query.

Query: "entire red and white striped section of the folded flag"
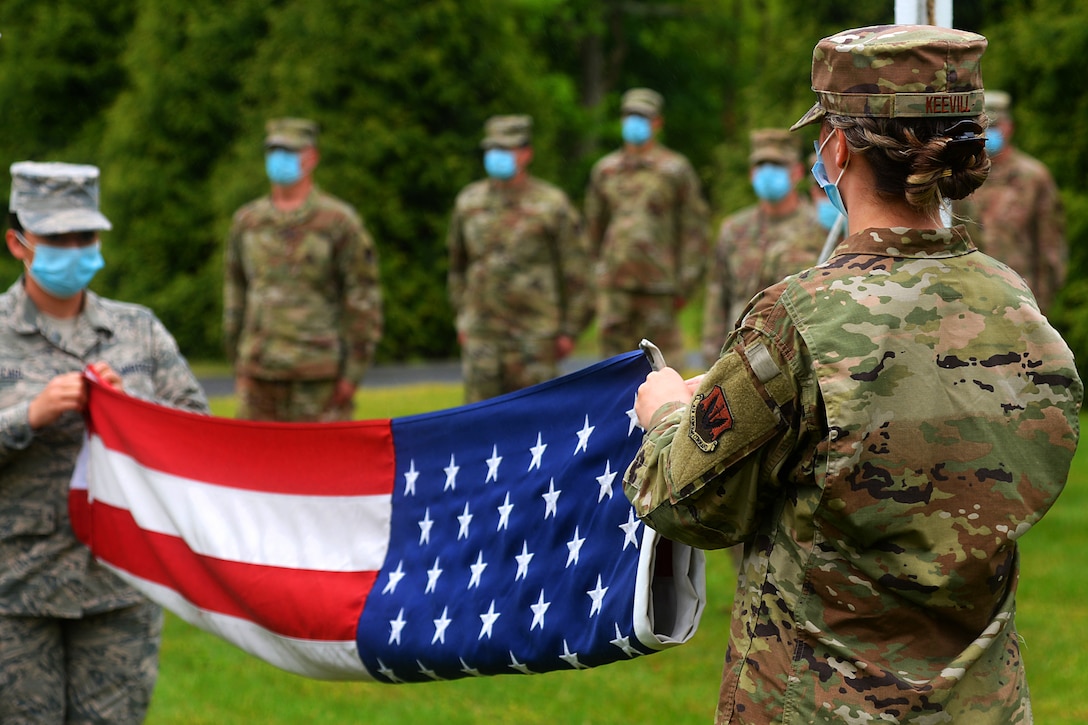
[70,385,394,679]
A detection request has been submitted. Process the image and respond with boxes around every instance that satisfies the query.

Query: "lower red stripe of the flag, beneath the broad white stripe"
[87,491,378,641]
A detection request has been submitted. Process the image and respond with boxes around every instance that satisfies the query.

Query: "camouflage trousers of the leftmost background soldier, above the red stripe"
[235,377,355,422]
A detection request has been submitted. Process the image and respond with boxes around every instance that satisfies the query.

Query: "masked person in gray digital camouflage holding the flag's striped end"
[0,161,208,723]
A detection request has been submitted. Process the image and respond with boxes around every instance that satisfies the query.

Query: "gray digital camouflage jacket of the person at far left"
[0,280,208,617]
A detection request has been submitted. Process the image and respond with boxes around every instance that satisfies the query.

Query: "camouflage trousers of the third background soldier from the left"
[597,290,684,363]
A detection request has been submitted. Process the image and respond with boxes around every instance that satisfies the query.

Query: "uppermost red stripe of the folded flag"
[82,382,395,496]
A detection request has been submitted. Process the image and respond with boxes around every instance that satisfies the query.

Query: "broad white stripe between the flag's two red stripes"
[88,437,392,572]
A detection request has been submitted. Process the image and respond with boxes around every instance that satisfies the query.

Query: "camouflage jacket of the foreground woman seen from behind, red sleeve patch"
[625,228,1084,725]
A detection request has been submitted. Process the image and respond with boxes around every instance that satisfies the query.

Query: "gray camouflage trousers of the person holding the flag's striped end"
[0,602,162,724]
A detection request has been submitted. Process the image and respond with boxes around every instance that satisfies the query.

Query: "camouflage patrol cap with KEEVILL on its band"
[790,25,987,131]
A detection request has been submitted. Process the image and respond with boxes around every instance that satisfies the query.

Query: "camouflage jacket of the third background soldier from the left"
[585,145,709,297]
